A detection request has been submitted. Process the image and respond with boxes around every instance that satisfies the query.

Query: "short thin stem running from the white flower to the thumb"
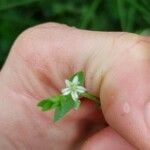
[81,92,101,107]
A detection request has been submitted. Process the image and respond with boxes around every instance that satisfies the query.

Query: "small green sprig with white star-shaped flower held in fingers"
[37,71,100,122]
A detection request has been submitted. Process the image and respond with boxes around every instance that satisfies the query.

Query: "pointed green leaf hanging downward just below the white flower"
[54,95,74,122]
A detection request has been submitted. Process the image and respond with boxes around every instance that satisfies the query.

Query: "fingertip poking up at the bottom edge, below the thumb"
[82,127,136,150]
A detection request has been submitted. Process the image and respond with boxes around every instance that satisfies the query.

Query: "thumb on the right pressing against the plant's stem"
[101,40,150,150]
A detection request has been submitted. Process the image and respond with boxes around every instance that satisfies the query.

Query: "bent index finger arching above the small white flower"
[1,23,137,98]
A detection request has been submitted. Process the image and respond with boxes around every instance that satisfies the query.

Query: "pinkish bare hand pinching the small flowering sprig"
[0,23,150,150]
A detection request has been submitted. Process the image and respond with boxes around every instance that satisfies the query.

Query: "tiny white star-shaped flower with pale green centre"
[61,76,86,101]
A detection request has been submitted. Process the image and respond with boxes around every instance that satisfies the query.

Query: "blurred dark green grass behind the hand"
[0,0,150,67]
